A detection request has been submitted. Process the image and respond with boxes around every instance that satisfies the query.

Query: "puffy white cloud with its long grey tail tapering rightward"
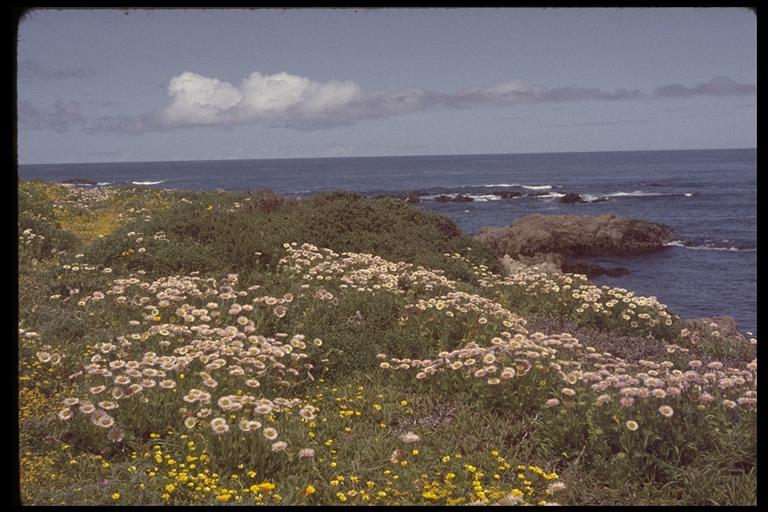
[146,72,643,130]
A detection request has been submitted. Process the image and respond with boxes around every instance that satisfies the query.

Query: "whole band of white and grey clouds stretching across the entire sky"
[20,71,757,134]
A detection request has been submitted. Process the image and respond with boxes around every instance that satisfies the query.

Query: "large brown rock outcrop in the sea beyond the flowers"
[476,214,677,257]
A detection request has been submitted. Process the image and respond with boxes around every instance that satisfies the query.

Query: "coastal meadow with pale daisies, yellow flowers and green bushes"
[18,181,757,505]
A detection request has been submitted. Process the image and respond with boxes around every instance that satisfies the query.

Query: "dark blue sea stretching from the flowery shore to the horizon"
[19,149,757,334]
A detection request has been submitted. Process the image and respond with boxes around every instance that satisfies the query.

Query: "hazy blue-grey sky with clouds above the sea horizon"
[17,8,757,164]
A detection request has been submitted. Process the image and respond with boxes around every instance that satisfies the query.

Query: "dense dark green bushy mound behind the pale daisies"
[87,191,498,280]
